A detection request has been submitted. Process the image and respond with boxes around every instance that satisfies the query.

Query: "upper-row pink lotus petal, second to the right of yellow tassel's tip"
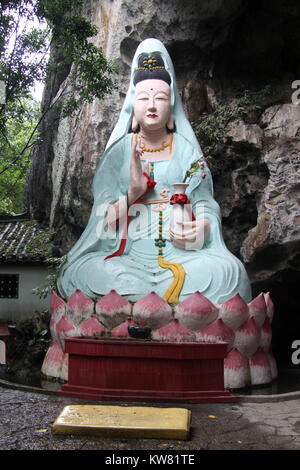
[219,293,249,331]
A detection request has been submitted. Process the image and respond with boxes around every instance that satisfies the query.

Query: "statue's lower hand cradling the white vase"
[170,219,210,250]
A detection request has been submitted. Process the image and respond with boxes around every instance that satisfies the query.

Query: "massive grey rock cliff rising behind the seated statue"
[26,0,300,362]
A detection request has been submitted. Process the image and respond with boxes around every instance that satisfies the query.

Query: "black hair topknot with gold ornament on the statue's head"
[133,53,171,85]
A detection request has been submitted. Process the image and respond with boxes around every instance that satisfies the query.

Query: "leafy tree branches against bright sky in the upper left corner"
[0,0,117,114]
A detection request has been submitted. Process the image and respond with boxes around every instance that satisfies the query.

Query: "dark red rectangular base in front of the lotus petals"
[57,338,235,403]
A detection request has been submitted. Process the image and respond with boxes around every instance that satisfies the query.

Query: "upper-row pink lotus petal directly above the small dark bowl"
[132,291,172,330]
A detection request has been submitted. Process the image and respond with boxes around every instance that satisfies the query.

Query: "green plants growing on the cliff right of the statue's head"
[193,85,271,161]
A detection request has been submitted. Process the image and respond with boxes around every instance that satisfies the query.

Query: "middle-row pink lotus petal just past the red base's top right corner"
[233,316,260,358]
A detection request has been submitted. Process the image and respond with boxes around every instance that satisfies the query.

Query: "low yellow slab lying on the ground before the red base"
[52,405,191,440]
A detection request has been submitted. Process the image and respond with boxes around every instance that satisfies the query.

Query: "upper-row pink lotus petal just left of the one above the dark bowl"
[96,289,131,329]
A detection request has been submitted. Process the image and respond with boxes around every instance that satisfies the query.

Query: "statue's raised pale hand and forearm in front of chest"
[128,135,149,205]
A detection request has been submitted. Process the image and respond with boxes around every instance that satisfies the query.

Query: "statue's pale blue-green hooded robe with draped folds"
[57,39,251,303]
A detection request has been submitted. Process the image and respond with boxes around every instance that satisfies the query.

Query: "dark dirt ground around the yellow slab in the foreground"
[0,383,300,456]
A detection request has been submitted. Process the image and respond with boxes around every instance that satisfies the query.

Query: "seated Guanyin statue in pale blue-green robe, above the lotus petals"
[57,39,251,304]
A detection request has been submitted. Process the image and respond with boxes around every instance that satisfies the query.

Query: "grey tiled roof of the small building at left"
[0,217,53,263]
